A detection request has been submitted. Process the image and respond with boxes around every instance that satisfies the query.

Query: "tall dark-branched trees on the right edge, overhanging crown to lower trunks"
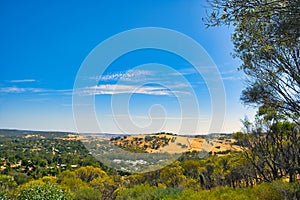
[205,0,300,186]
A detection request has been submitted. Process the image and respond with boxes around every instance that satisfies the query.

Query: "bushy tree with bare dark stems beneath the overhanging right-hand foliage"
[235,107,300,182]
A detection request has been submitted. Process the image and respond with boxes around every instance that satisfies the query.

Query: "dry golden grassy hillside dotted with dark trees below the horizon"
[111,133,242,156]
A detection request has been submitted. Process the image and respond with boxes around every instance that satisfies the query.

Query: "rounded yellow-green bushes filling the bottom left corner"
[0,166,110,200]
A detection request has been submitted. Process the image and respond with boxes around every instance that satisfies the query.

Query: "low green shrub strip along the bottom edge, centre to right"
[116,181,300,200]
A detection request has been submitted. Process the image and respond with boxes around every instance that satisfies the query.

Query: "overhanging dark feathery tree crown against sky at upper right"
[205,0,300,121]
